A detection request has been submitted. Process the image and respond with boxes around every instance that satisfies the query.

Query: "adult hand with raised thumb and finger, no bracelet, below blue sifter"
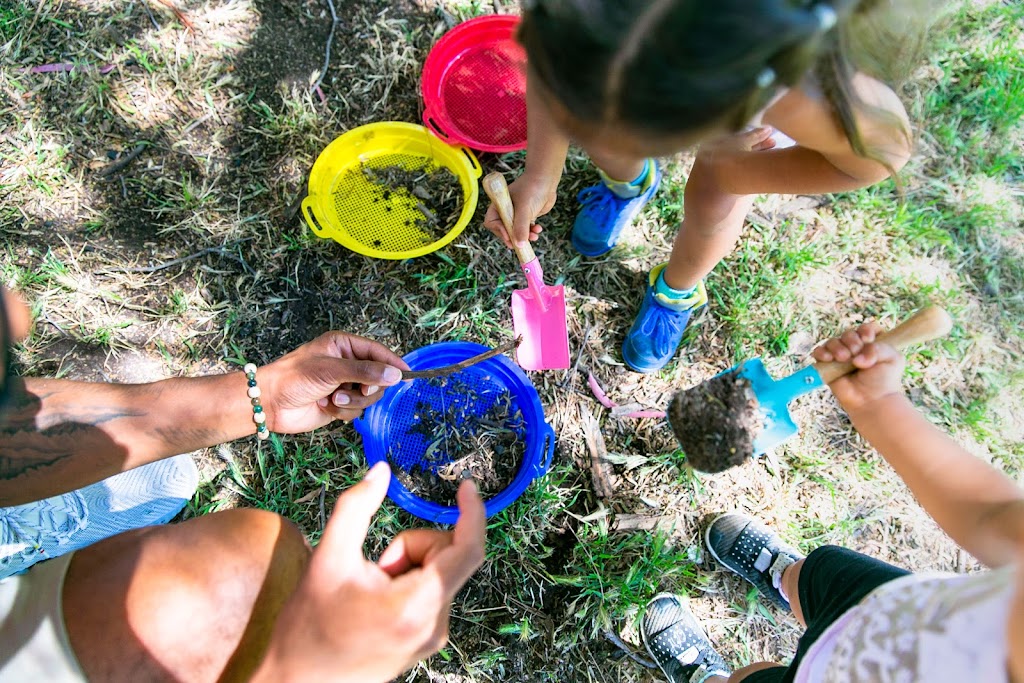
[255,463,486,683]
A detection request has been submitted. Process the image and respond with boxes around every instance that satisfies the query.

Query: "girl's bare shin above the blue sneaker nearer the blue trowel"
[665,154,754,290]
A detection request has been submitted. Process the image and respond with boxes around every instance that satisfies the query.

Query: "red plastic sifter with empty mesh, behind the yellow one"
[421,14,526,153]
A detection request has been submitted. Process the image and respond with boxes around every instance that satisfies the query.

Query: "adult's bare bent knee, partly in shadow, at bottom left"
[65,510,309,681]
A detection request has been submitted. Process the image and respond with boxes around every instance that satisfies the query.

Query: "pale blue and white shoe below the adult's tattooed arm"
[0,455,199,579]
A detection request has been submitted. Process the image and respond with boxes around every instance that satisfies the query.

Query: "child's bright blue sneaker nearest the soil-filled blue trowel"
[623,263,708,373]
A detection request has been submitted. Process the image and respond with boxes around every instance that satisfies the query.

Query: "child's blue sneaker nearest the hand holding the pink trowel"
[572,161,662,256]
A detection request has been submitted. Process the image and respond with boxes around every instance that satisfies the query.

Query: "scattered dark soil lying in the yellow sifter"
[359,164,462,242]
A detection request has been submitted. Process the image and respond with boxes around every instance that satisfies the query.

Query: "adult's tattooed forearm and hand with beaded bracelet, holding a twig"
[0,332,408,506]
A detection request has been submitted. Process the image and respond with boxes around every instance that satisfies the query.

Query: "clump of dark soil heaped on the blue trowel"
[669,370,764,472]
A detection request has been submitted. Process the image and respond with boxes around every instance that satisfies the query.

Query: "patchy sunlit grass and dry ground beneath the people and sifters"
[0,0,1024,682]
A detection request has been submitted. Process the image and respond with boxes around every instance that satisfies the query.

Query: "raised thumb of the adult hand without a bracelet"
[313,462,391,575]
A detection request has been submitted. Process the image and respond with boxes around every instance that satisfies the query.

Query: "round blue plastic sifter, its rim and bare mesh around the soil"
[353,342,555,524]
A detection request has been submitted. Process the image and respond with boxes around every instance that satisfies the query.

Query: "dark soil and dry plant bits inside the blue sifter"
[388,374,526,506]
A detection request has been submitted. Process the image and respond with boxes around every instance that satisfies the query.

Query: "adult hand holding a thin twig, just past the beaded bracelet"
[259,332,409,434]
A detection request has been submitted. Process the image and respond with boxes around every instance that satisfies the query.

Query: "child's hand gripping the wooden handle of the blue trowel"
[813,323,904,413]
